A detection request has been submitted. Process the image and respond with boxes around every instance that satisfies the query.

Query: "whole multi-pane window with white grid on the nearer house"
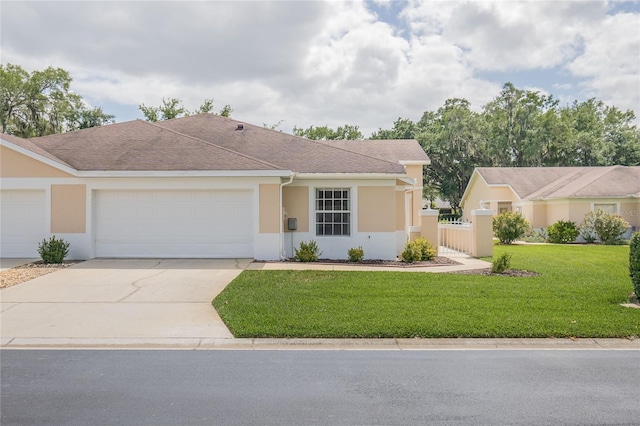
[316,188,351,236]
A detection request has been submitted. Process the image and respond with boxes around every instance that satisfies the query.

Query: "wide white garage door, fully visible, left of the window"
[94,191,253,258]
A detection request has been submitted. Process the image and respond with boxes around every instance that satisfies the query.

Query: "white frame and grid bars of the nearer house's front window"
[314,187,353,237]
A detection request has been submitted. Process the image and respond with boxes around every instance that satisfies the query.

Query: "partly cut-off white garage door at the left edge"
[0,189,48,258]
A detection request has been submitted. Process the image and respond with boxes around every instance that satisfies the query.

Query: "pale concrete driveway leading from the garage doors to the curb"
[0,259,251,346]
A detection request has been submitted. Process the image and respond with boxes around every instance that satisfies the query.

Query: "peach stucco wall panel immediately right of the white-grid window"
[358,186,396,232]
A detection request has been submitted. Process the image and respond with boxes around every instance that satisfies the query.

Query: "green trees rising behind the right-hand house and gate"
[298,83,640,207]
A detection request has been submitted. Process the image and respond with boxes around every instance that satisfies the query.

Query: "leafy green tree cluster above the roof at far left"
[0,64,114,138]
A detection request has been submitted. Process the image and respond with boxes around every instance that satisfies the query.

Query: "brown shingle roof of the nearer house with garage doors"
[3,114,429,174]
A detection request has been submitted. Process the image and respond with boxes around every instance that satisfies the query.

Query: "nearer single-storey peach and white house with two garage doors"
[0,114,429,260]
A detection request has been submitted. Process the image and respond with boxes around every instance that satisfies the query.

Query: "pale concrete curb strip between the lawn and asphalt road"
[1,338,640,351]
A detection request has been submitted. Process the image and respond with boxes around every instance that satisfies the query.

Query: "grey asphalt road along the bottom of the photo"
[0,350,640,426]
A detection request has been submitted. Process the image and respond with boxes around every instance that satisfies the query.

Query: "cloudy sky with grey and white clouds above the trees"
[0,0,640,136]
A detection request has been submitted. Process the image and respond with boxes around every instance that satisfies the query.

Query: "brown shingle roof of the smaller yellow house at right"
[470,166,640,200]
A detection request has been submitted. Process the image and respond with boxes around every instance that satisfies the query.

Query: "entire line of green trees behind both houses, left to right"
[0,64,640,207]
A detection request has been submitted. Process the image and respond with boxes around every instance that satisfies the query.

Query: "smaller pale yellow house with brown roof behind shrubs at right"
[460,166,640,230]
